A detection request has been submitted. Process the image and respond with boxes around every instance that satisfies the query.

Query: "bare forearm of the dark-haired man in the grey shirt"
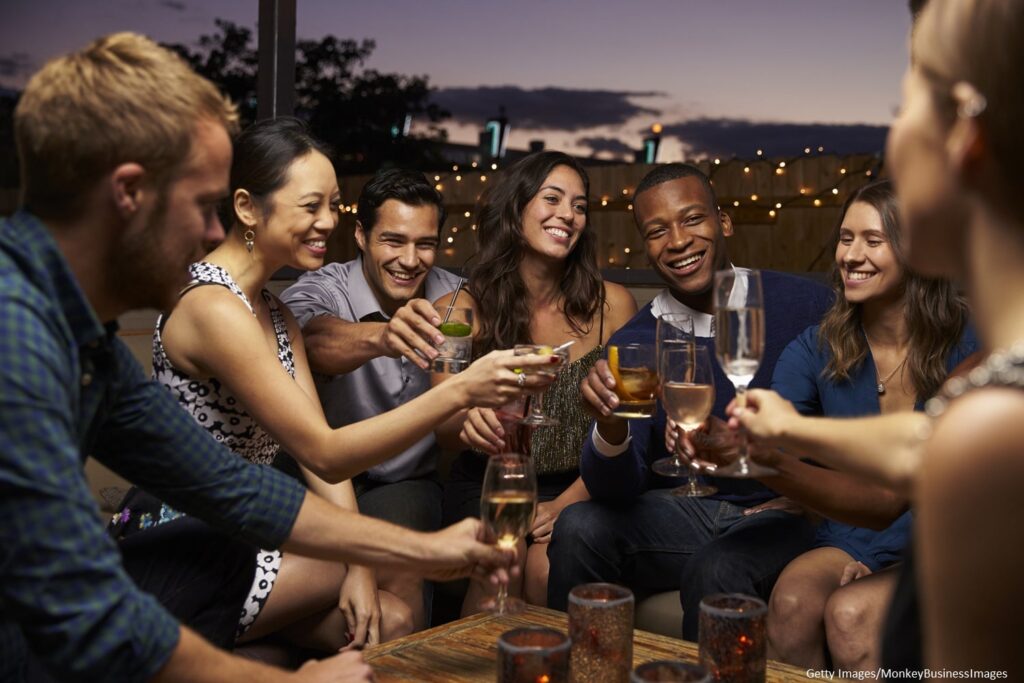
[302,315,387,375]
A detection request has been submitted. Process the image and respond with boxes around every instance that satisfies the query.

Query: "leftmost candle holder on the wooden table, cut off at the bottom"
[498,627,571,683]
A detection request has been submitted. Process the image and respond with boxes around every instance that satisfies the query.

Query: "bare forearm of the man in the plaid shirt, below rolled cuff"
[282,494,428,569]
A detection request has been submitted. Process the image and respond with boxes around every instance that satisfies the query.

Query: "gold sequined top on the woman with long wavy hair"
[529,344,604,475]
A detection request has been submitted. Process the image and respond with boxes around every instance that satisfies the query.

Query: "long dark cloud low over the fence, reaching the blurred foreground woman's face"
[662,119,889,157]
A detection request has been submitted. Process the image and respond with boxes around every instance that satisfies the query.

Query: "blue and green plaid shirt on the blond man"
[0,212,304,681]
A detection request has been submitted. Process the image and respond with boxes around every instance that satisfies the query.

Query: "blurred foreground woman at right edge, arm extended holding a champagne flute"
[734,0,1024,680]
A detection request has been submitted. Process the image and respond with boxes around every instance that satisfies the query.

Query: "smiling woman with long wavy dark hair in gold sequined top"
[439,151,636,612]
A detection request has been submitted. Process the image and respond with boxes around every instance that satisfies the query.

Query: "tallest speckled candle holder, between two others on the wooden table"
[568,584,633,683]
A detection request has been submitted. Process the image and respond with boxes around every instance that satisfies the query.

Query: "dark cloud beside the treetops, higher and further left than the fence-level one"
[432,85,664,130]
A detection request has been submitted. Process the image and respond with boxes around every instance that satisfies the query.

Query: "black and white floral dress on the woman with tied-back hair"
[121,261,295,637]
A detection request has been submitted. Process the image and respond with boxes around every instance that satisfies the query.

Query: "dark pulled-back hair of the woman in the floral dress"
[220,117,331,227]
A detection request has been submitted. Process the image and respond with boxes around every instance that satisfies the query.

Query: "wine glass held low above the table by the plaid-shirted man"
[480,453,537,614]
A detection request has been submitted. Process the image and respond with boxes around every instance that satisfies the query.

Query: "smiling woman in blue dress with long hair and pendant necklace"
[768,180,976,670]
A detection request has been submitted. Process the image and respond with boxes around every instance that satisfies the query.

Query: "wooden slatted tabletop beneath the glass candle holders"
[365,607,807,683]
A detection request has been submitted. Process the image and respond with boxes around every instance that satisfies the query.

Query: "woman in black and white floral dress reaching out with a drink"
[115,118,551,651]
